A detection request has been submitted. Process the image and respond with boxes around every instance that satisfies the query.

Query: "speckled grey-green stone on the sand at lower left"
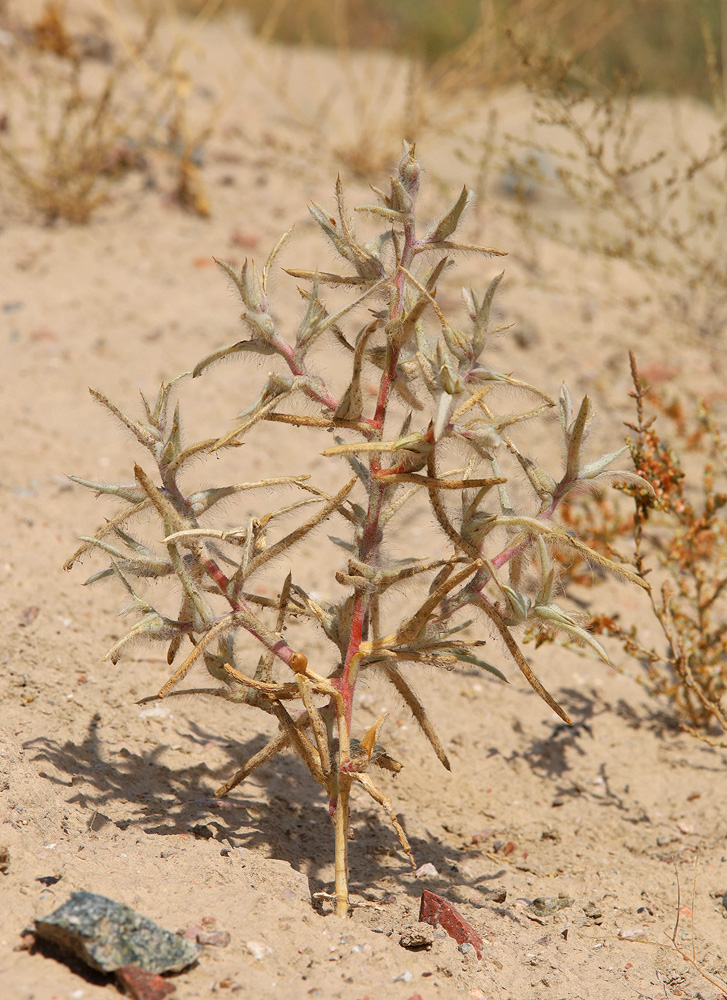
[35,892,202,973]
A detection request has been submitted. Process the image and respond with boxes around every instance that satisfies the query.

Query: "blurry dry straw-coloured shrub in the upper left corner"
[0,0,212,223]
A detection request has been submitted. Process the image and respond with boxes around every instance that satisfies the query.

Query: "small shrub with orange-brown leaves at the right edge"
[572,354,727,736]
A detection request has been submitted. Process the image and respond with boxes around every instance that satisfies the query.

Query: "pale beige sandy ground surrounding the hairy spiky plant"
[0,3,727,1000]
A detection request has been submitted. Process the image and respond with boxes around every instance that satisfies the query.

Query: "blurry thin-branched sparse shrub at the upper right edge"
[461,33,727,336]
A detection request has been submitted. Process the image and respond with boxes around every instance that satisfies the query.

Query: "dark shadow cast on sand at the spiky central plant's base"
[25,715,472,900]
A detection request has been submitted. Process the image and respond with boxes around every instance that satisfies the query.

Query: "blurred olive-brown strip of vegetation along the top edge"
[180,0,727,100]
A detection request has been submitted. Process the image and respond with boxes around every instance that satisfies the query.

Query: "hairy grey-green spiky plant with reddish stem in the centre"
[67,143,648,914]
